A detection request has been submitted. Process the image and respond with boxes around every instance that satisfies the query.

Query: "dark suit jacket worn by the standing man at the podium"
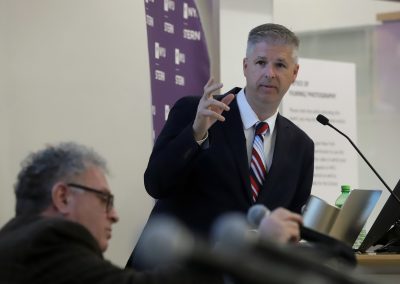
[144,88,314,235]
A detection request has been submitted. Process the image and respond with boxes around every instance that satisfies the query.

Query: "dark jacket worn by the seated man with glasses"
[0,216,222,284]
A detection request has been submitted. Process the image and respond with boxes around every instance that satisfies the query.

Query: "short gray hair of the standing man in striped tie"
[246,23,300,62]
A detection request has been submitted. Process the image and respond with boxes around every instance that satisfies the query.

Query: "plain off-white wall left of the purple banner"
[0,0,153,265]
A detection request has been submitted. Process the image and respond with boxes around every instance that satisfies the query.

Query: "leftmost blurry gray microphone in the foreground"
[138,216,293,284]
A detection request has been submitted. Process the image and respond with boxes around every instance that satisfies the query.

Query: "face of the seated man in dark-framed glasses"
[67,167,118,252]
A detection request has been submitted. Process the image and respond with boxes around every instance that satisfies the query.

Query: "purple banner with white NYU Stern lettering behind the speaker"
[145,0,210,138]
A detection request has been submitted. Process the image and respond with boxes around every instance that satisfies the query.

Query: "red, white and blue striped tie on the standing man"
[250,122,269,202]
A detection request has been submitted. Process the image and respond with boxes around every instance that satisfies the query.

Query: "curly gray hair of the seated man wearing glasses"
[14,142,108,215]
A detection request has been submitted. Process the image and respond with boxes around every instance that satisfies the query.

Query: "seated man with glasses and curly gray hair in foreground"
[0,143,219,284]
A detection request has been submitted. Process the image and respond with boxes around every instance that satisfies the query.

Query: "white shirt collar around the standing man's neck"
[236,88,278,133]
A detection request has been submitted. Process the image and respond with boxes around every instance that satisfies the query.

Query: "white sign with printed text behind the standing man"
[281,58,358,204]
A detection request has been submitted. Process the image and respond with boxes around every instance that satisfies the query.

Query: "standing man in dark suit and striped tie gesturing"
[128,24,314,267]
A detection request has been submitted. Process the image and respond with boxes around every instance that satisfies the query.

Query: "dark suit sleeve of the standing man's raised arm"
[144,97,201,199]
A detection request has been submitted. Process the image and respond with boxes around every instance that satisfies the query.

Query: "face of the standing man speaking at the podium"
[243,42,299,109]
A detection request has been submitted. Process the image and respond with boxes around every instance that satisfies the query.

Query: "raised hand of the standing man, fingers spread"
[193,78,235,141]
